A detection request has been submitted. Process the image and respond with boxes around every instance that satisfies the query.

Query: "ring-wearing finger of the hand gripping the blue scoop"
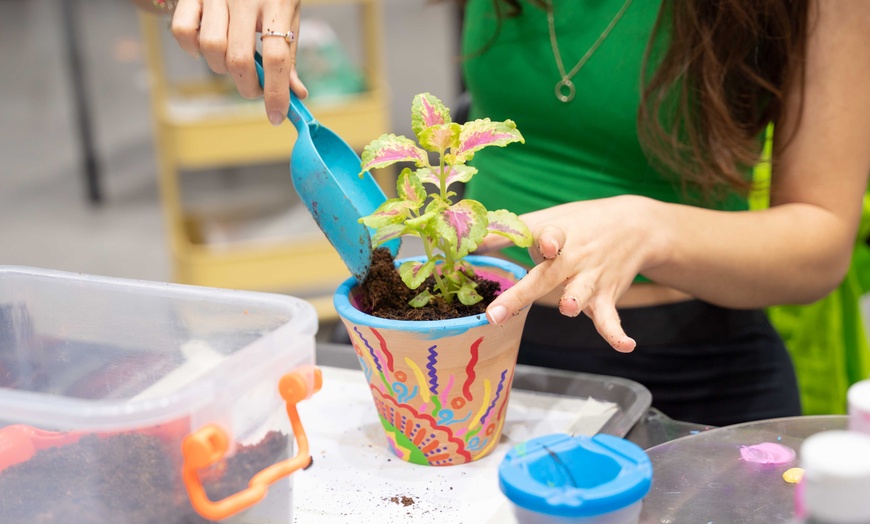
[262,3,298,125]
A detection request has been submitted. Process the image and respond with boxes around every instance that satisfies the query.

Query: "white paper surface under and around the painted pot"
[293,366,617,524]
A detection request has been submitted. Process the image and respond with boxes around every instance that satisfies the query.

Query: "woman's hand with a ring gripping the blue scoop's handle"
[172,0,308,125]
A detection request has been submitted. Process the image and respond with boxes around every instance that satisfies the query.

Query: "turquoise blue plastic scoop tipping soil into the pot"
[255,53,400,282]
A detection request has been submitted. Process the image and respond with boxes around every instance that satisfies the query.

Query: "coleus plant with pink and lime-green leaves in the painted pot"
[360,93,532,307]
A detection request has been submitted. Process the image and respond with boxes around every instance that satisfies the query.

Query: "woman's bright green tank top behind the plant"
[462,0,748,265]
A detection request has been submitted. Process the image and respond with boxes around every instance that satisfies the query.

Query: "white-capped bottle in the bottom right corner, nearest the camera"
[801,430,870,524]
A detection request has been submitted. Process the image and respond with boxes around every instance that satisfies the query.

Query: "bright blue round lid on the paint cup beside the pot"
[498,434,652,517]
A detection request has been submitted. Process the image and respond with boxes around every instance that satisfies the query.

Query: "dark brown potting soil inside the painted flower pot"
[360,248,500,320]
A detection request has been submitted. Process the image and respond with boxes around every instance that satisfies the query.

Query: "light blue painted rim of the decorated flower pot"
[332,255,526,333]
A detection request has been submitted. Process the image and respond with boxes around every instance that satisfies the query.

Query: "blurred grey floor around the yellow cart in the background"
[0,0,870,336]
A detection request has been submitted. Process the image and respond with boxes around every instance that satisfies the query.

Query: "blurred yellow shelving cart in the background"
[140,0,389,319]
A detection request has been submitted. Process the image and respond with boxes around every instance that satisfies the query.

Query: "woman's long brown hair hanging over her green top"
[484,0,810,199]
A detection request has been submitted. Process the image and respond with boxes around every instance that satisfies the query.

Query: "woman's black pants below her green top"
[519,300,801,426]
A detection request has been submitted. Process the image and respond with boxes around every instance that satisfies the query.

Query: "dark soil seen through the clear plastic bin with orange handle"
[0,432,288,524]
